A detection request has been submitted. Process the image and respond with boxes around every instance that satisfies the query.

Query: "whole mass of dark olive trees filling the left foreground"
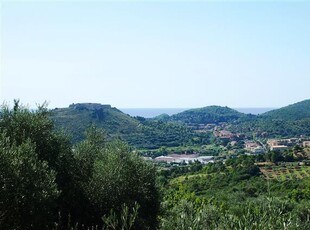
[0,101,159,229]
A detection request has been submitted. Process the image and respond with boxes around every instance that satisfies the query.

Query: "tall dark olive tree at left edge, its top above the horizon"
[0,101,74,229]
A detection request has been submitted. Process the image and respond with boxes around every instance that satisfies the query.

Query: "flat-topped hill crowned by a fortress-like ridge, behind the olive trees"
[51,103,193,148]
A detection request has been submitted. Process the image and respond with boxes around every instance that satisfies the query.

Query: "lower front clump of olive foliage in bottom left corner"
[0,133,59,229]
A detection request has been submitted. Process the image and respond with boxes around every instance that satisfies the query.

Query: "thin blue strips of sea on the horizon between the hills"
[120,108,276,118]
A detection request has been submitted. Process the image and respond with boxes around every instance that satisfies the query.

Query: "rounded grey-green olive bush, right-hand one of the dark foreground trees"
[75,141,159,229]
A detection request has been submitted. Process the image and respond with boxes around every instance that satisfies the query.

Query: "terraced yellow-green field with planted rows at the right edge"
[260,165,310,181]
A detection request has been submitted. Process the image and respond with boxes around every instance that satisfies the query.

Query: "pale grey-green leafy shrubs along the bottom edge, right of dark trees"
[161,198,310,230]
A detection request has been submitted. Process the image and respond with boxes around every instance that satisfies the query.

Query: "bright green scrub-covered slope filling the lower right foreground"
[161,156,310,229]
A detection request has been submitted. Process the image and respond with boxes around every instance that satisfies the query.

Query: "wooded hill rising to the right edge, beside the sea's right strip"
[261,100,310,121]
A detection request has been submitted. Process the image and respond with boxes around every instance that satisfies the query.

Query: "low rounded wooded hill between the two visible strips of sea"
[155,105,246,125]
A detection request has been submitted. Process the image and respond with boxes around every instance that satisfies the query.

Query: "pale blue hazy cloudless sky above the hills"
[0,0,310,108]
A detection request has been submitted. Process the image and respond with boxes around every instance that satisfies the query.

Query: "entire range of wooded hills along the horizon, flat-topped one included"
[51,100,310,146]
